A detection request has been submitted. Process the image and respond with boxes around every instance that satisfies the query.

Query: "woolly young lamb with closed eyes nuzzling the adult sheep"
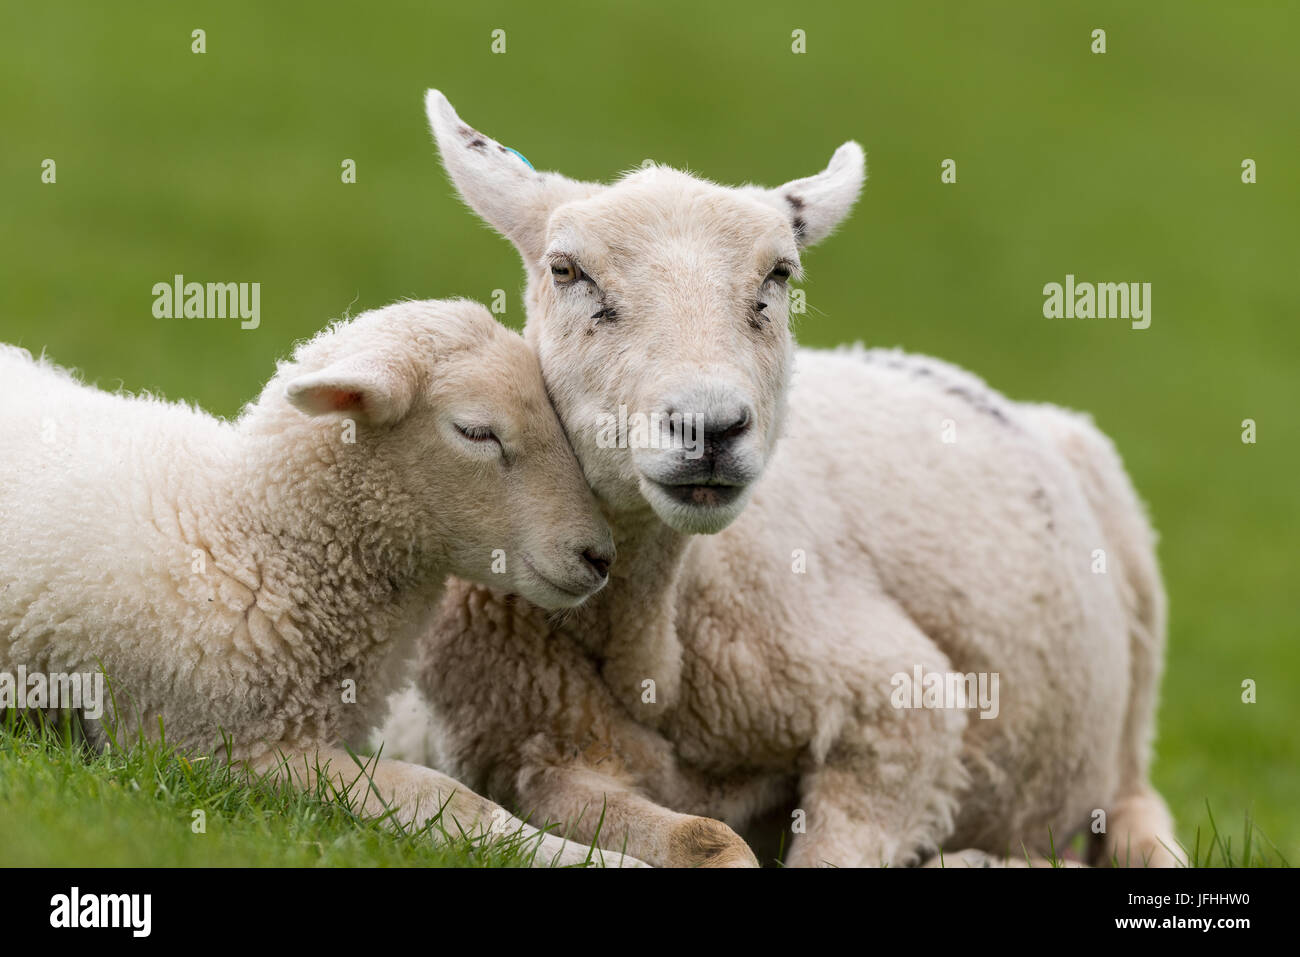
[0,300,638,863]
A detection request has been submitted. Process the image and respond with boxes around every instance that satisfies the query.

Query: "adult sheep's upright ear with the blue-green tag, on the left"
[424,90,602,265]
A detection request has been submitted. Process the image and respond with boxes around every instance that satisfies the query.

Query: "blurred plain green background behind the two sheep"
[0,0,1300,861]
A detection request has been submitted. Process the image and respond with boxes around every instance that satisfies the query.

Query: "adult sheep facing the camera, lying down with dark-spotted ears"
[380,91,1175,866]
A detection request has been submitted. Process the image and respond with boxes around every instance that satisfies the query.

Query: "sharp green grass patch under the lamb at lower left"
[0,711,613,867]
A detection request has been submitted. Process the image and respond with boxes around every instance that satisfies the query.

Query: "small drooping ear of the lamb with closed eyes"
[285,355,415,425]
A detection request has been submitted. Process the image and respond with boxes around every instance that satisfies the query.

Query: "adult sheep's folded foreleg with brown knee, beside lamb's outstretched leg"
[523,765,758,867]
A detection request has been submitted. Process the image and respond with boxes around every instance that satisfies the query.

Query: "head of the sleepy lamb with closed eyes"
[260,300,614,607]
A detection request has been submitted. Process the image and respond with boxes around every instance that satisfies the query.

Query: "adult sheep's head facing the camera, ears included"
[425,90,863,533]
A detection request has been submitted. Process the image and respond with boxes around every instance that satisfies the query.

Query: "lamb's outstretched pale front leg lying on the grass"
[251,748,645,867]
